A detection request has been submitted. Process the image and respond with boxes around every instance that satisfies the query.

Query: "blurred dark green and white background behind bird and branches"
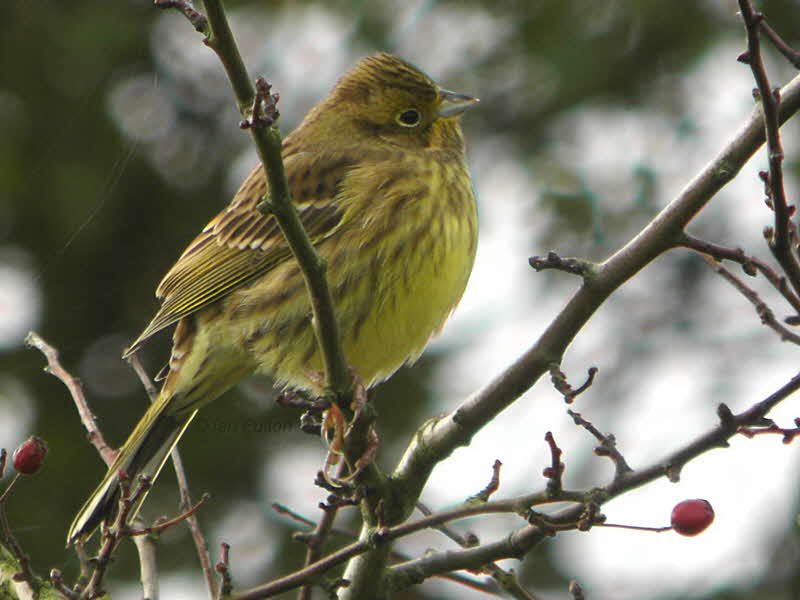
[0,0,800,600]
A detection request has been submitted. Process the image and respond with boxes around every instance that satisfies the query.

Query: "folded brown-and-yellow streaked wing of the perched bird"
[125,153,353,356]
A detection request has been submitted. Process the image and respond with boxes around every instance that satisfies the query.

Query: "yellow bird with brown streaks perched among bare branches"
[68,53,477,542]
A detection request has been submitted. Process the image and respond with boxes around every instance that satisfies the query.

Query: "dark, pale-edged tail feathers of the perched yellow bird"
[67,389,197,544]
